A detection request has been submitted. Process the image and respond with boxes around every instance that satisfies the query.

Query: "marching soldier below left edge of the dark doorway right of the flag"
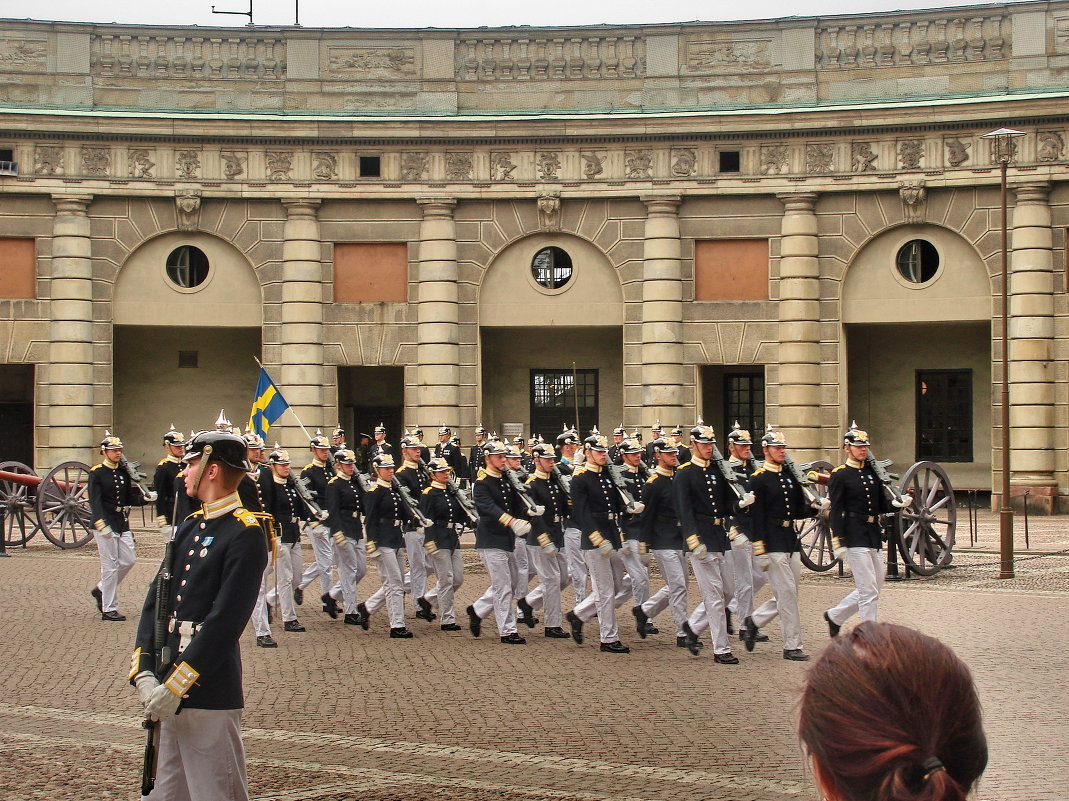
[320,448,368,626]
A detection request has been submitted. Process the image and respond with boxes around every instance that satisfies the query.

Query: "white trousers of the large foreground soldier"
[141,709,249,801]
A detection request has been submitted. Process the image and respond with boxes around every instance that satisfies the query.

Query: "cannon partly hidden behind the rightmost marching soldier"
[797,461,958,575]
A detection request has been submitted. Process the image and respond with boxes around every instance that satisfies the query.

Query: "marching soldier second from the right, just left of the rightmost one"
[744,426,812,662]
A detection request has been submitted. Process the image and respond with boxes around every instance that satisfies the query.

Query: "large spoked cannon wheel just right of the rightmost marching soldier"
[898,462,958,575]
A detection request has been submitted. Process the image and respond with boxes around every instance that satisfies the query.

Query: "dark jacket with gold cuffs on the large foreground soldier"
[129,493,267,712]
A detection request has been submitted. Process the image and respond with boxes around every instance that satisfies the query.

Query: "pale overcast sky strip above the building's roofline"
[6,0,1026,28]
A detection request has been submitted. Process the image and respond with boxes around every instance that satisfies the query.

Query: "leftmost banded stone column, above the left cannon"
[40,195,96,468]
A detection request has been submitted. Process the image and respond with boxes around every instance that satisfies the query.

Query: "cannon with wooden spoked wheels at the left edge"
[0,462,93,549]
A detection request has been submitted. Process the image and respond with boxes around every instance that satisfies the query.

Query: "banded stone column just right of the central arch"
[633,195,694,427]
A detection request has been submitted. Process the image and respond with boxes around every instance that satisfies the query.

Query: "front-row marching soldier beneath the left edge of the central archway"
[466,438,534,645]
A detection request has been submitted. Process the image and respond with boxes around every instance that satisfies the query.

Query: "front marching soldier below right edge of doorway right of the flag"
[357,453,413,640]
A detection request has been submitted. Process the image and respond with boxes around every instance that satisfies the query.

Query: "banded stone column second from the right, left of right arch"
[773,192,821,462]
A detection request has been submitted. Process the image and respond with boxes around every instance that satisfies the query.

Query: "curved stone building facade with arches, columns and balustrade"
[0,1,1069,509]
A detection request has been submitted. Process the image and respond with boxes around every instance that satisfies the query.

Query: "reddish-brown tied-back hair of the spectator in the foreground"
[799,622,988,801]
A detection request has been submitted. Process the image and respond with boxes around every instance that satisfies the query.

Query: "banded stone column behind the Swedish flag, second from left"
[277,199,326,438]
